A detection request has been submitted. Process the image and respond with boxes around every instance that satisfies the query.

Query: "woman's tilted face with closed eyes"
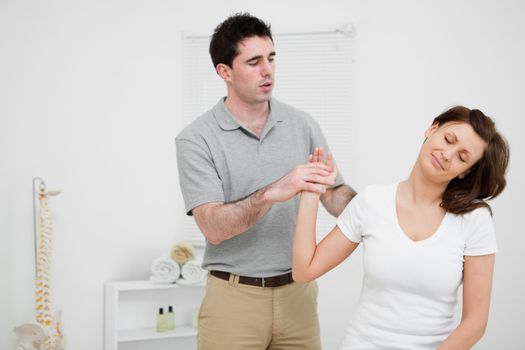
[418,122,487,183]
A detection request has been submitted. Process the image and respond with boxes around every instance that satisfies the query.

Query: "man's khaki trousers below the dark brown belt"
[198,275,321,350]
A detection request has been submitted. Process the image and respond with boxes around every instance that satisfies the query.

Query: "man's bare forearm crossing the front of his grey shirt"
[195,187,272,244]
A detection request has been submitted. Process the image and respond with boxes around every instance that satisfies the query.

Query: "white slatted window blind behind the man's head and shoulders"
[182,28,354,246]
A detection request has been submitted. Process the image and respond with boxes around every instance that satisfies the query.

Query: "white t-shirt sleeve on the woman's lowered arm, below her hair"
[464,208,498,256]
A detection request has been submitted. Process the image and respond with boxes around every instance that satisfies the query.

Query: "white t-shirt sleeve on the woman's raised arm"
[337,190,366,243]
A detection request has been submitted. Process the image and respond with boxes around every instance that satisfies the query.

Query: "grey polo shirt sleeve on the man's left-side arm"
[175,138,224,215]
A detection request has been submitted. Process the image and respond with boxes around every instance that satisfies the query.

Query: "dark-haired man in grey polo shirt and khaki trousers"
[176,14,355,350]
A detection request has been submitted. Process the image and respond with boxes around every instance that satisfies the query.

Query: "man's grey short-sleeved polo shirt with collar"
[175,98,343,277]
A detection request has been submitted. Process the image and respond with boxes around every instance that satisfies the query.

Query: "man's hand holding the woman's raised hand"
[265,155,335,203]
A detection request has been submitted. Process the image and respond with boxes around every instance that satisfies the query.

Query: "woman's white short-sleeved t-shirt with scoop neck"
[337,184,497,350]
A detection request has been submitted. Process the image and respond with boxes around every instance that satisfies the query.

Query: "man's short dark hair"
[210,12,273,67]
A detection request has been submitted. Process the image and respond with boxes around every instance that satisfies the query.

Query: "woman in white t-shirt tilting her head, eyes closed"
[292,106,509,350]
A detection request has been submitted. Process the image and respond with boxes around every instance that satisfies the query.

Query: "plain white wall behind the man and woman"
[0,0,525,350]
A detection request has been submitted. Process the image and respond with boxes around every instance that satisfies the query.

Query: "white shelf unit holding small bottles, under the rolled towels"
[104,281,205,350]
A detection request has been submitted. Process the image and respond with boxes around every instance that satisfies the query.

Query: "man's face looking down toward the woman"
[219,36,275,104]
